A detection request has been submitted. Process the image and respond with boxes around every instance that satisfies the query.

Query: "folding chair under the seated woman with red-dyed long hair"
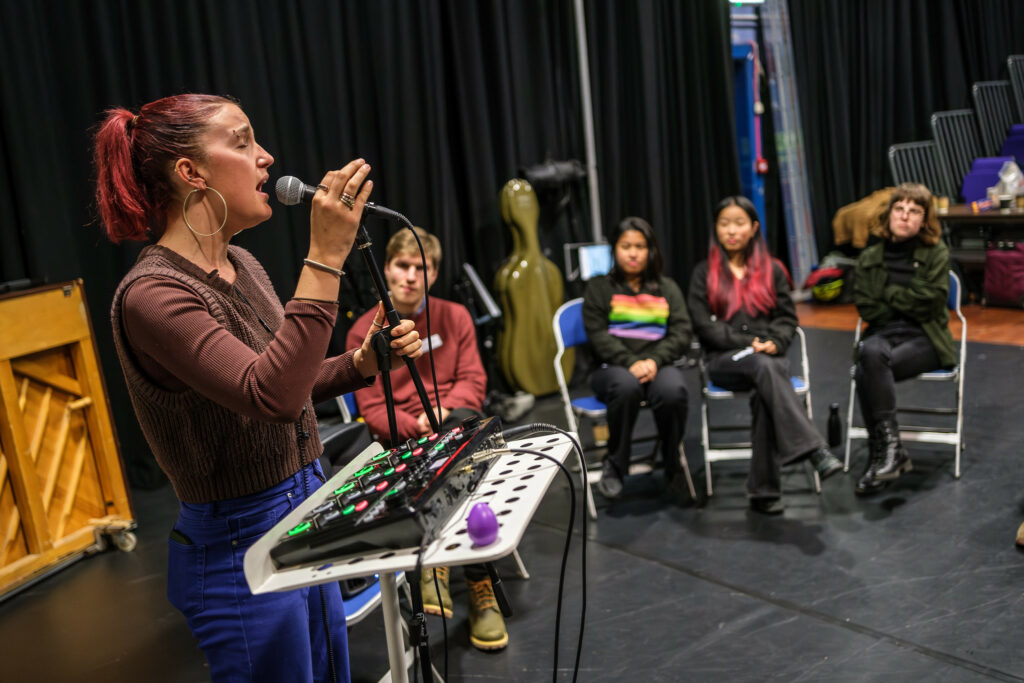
[700,328,821,498]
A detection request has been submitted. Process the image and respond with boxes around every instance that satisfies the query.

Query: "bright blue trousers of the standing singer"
[167,462,349,683]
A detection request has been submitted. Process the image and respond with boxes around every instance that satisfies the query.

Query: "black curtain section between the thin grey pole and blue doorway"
[587,0,739,282]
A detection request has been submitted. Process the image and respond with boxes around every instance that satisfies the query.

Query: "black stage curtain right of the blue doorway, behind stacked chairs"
[788,0,1024,253]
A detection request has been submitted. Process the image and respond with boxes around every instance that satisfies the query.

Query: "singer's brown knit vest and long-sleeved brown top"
[111,246,368,503]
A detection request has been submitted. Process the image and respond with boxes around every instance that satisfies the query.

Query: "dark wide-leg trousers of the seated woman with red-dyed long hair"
[708,352,825,498]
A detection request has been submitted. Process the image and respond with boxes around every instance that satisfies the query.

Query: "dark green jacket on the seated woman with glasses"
[853,242,958,369]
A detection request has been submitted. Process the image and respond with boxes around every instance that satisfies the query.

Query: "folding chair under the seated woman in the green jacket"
[844,270,967,479]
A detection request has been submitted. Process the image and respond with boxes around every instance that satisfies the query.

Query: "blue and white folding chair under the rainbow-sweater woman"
[552,298,696,519]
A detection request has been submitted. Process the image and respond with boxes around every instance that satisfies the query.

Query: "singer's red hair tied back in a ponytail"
[93,93,234,243]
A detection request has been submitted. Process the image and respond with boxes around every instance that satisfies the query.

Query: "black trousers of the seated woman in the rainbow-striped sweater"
[590,366,689,475]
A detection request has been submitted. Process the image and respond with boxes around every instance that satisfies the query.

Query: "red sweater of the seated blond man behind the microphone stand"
[346,297,487,439]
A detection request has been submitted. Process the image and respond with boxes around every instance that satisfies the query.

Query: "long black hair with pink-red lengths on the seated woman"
[708,196,790,321]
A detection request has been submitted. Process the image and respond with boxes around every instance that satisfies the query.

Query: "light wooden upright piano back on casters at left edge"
[0,280,135,596]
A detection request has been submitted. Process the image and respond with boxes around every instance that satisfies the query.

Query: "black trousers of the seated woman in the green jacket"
[854,324,939,433]
